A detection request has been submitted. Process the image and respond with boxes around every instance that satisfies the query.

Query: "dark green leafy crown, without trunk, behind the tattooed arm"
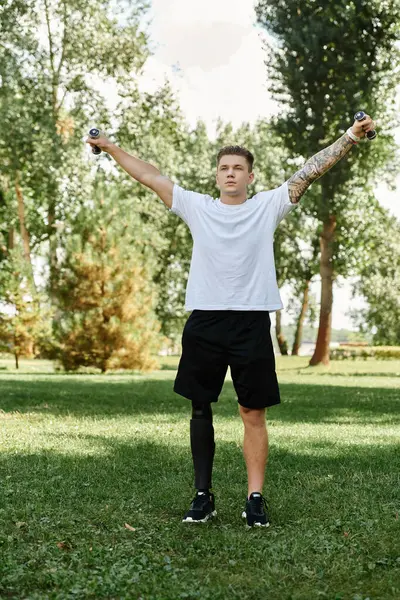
[256,0,400,199]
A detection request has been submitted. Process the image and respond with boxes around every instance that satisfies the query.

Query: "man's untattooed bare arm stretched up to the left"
[86,135,174,208]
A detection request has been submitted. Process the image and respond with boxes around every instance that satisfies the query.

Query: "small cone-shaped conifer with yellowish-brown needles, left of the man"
[55,184,159,373]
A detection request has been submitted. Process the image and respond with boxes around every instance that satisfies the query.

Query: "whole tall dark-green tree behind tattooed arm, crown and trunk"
[256,0,400,365]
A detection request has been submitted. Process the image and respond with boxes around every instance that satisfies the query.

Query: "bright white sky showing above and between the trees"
[129,0,400,329]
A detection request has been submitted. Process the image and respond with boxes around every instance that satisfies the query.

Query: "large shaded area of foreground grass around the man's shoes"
[0,433,399,598]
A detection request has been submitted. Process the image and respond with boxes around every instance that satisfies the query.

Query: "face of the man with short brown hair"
[216,154,254,197]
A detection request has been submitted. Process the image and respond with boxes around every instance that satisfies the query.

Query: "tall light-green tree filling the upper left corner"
[0,0,149,290]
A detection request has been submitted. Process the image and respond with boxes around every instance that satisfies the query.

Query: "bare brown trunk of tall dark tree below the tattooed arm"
[310,215,336,366]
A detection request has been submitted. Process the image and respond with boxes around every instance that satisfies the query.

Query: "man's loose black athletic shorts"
[174,310,280,408]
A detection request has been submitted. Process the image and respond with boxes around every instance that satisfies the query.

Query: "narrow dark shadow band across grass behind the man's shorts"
[0,376,400,424]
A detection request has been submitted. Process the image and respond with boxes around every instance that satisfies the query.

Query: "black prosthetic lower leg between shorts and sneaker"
[190,402,215,491]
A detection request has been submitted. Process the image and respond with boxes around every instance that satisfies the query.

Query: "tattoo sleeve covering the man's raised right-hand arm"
[288,133,354,204]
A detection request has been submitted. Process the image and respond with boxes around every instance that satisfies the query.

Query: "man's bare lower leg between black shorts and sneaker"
[239,406,268,496]
